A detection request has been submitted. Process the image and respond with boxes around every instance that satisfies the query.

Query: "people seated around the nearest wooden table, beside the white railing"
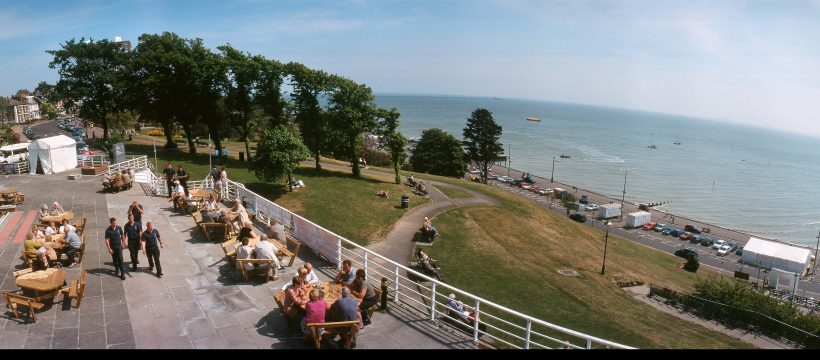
[283,260,379,336]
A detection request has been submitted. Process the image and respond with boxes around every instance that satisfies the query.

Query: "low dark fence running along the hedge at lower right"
[649,283,820,348]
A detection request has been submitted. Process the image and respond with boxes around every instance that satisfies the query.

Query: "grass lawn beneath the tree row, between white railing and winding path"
[126,143,430,245]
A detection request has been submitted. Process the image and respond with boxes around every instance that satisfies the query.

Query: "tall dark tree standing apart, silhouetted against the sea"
[462,108,504,184]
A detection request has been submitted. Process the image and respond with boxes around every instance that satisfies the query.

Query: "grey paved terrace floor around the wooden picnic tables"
[0,174,475,349]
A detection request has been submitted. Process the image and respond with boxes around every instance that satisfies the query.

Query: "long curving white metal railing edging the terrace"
[139,170,632,349]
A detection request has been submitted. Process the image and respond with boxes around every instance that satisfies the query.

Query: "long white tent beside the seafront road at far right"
[741,237,811,274]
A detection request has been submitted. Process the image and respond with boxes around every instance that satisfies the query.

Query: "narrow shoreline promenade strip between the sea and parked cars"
[489,164,814,250]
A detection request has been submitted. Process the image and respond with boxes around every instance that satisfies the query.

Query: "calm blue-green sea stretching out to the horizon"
[376,94,820,247]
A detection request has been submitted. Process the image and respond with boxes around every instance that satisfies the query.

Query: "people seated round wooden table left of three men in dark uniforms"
[23,201,82,269]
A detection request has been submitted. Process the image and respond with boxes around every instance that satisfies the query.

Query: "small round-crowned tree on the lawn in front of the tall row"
[253,125,310,191]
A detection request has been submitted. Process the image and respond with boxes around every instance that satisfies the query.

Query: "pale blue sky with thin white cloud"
[0,0,820,137]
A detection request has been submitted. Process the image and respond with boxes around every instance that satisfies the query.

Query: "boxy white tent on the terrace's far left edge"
[28,135,77,174]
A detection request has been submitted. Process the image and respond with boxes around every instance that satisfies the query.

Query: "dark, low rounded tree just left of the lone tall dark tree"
[410,129,467,178]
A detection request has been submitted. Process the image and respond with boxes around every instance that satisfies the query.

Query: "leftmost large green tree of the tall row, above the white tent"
[46,38,130,139]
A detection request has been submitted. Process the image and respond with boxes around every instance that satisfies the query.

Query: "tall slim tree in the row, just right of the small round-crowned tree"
[286,62,331,170]
